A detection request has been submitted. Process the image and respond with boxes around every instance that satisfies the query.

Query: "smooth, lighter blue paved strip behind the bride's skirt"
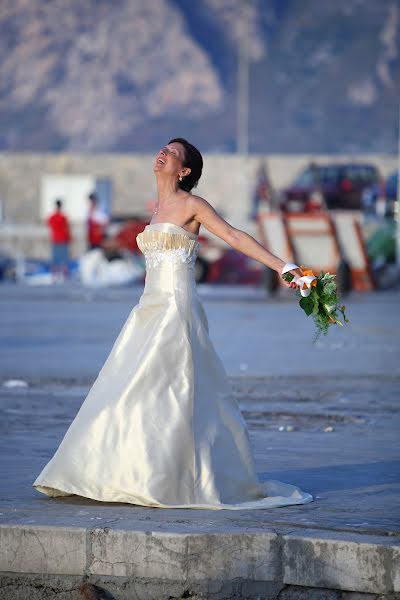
[0,285,400,380]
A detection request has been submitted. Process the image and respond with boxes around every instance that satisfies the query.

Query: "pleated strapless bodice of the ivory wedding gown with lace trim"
[136,223,199,268]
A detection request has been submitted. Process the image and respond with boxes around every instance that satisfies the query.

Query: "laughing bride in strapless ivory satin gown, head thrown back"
[32,138,313,510]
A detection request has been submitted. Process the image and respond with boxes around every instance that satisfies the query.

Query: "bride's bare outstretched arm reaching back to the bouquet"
[191,196,303,287]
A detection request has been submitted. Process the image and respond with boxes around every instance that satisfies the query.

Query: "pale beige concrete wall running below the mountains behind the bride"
[0,154,397,256]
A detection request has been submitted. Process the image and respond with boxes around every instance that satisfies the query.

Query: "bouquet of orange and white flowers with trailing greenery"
[282,263,349,342]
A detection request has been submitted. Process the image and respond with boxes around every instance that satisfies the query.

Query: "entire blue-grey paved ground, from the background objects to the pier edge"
[0,286,400,591]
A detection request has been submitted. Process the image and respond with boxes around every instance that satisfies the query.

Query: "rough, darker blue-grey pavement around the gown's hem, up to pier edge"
[0,377,400,535]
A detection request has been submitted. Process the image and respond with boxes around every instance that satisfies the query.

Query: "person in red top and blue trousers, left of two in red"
[47,200,71,282]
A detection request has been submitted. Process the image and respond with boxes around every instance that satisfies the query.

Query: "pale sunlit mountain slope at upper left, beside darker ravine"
[0,0,223,151]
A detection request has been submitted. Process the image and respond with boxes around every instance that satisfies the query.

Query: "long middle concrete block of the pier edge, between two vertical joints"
[88,529,280,581]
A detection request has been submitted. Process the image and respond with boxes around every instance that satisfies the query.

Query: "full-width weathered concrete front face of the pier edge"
[0,524,400,594]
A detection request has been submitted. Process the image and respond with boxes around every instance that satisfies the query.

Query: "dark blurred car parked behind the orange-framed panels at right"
[281,164,381,212]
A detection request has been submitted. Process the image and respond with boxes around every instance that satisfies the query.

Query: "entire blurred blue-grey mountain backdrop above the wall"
[0,0,400,152]
